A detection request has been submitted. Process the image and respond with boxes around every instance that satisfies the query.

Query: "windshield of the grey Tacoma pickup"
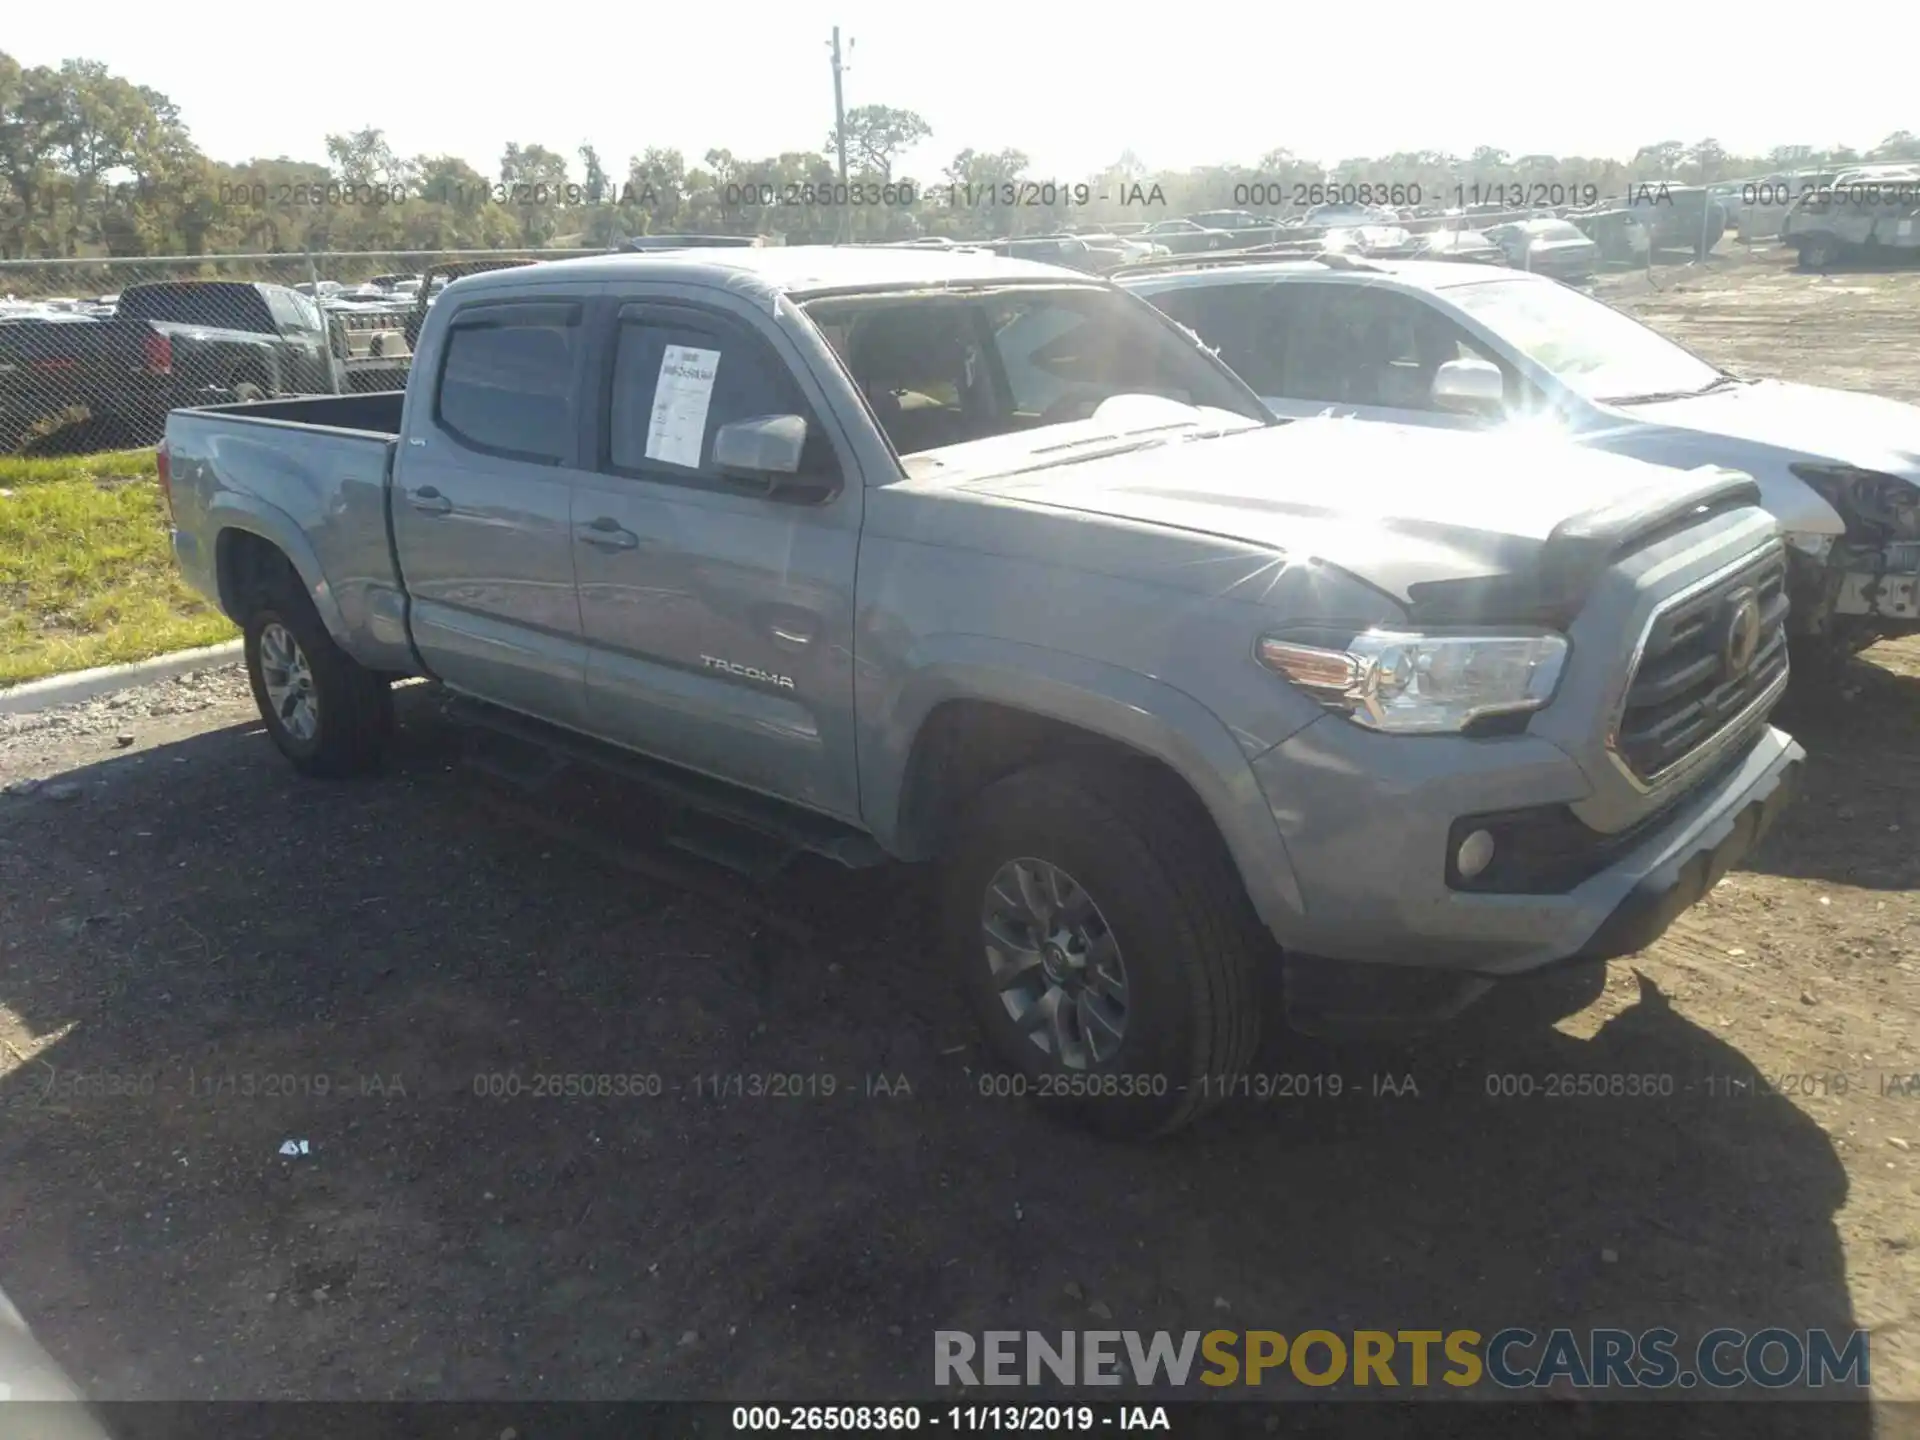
[806,286,1269,455]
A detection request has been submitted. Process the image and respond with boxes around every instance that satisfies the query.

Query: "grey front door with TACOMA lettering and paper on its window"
[574,294,862,818]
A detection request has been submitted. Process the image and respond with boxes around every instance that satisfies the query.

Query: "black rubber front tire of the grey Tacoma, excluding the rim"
[941,760,1277,1139]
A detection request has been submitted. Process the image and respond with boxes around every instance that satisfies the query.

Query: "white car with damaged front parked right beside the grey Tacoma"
[1121,261,1920,662]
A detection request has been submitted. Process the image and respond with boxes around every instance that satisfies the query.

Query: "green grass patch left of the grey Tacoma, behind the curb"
[0,449,234,685]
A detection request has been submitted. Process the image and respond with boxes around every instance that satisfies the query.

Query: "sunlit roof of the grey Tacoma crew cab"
[439,246,1096,296]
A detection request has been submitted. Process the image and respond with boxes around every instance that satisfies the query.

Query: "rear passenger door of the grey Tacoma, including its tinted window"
[392,286,593,728]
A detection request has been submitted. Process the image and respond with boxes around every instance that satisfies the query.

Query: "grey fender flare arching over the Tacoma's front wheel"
[860,634,1306,935]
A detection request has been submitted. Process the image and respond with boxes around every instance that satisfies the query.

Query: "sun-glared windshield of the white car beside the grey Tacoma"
[1446,280,1724,401]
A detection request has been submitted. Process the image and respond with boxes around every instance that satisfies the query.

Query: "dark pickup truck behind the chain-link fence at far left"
[0,280,342,451]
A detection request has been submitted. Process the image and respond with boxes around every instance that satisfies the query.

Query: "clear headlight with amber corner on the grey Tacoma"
[1260,630,1567,735]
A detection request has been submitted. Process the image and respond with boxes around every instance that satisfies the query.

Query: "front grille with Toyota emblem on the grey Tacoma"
[1607,543,1788,787]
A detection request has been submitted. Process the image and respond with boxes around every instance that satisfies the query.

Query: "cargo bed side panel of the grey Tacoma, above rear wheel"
[167,407,415,672]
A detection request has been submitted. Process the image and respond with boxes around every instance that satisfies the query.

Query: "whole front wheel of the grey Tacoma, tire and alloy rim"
[943,760,1271,1139]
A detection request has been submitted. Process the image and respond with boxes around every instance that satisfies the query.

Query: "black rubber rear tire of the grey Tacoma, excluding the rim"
[244,578,394,780]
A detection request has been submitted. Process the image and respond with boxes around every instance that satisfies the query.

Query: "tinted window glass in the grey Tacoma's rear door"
[434,303,582,465]
